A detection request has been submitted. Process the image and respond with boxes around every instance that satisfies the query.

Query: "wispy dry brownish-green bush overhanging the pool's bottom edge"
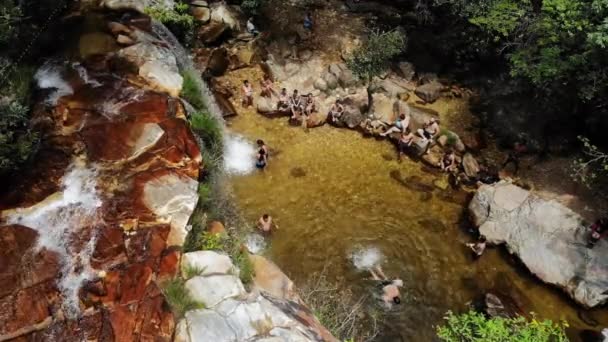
[298,267,381,341]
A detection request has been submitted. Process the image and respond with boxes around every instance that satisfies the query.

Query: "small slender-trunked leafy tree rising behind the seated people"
[346,31,407,108]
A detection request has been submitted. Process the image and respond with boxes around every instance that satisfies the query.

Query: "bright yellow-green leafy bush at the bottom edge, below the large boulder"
[437,310,568,342]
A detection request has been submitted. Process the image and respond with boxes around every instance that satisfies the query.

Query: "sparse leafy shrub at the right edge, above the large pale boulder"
[572,136,608,190]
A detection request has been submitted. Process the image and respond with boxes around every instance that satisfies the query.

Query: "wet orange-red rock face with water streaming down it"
[0,50,201,341]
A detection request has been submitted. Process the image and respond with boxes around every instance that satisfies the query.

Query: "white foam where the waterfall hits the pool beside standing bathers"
[224,134,255,175]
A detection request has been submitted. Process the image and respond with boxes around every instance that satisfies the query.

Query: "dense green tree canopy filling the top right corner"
[435,0,608,103]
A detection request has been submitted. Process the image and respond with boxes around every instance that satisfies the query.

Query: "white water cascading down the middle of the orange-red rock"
[6,161,102,317]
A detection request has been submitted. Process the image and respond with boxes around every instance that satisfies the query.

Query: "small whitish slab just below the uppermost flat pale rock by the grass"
[186,275,245,308]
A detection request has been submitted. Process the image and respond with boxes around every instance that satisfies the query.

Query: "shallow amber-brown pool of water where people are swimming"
[226,100,608,341]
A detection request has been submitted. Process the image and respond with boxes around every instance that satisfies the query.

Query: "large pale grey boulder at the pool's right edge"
[469,182,608,307]
